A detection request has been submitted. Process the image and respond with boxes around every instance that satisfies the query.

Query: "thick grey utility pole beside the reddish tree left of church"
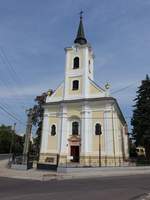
[23,108,33,164]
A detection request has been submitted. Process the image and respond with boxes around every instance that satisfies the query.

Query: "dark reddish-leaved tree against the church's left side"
[32,90,53,156]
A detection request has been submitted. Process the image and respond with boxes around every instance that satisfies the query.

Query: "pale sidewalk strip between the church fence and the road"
[0,161,150,181]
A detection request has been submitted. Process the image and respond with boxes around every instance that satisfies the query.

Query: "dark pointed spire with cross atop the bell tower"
[74,11,87,45]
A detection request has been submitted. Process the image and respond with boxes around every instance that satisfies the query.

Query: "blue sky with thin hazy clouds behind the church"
[0,0,150,133]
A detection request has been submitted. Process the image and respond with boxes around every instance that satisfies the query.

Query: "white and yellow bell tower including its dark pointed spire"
[64,12,94,99]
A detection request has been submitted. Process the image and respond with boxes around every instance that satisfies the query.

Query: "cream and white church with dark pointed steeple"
[39,14,129,167]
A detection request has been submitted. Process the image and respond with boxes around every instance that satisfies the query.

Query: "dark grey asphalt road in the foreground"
[0,175,150,200]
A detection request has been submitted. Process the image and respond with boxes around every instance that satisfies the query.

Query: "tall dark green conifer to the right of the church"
[131,75,150,160]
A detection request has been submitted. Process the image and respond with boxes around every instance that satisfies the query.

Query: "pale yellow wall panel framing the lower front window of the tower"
[68,76,82,95]
